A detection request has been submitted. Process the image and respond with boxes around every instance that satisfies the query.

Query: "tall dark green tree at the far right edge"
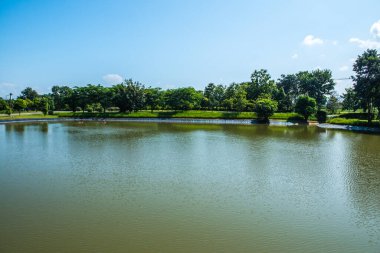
[352,49,380,124]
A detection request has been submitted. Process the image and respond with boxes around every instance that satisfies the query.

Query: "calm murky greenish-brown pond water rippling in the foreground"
[0,122,380,253]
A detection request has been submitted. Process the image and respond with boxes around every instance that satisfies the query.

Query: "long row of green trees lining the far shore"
[0,50,380,120]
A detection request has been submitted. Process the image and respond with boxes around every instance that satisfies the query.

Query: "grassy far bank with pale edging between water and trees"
[0,111,380,133]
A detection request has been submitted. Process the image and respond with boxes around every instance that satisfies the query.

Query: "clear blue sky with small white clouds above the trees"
[0,0,380,97]
